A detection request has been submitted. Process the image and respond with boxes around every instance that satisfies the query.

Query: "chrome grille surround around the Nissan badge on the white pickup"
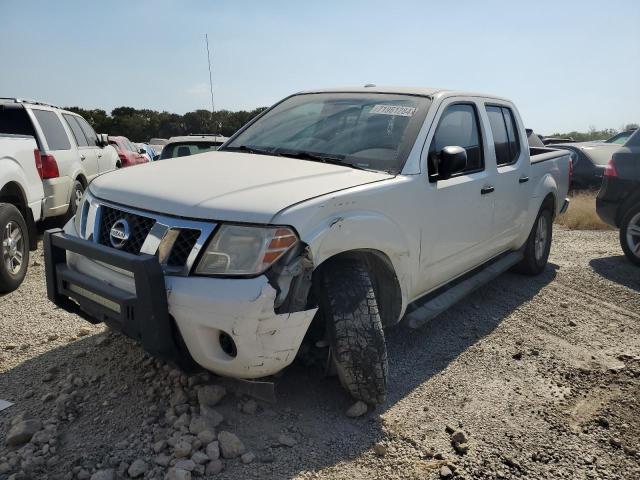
[87,196,218,277]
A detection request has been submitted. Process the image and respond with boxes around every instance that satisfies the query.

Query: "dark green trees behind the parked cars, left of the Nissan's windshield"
[66,107,266,142]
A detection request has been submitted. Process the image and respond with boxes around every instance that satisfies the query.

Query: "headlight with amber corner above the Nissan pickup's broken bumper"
[196,225,298,275]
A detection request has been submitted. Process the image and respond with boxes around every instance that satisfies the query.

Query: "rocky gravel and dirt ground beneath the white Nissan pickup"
[0,229,640,480]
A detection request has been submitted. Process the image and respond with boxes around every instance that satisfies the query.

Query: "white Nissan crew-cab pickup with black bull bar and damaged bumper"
[45,87,570,404]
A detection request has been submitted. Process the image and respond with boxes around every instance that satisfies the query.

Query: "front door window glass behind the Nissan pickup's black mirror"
[429,103,484,178]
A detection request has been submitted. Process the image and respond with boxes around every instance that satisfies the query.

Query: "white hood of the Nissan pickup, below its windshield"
[90,152,393,223]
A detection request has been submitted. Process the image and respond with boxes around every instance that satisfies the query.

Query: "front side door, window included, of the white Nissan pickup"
[419,98,494,292]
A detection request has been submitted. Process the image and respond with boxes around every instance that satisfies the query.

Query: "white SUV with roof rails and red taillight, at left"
[0,98,118,225]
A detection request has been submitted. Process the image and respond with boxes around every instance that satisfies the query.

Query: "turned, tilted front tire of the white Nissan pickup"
[318,260,389,405]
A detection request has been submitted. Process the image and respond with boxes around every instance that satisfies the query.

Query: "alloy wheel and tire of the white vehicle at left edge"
[0,203,29,293]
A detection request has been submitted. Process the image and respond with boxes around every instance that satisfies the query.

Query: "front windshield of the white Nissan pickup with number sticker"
[223,93,430,174]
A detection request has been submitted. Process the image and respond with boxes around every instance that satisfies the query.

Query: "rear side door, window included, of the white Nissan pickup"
[485,103,532,249]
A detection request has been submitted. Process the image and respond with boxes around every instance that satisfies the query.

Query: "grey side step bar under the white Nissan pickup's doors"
[403,251,523,328]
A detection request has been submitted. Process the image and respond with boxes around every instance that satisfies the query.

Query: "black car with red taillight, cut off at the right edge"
[596,130,640,265]
